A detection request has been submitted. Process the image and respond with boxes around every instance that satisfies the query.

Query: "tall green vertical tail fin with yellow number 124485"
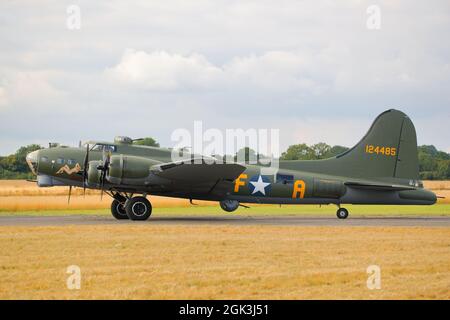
[280,109,419,180]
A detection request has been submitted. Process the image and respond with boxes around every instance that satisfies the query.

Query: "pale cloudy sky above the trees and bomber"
[0,0,450,155]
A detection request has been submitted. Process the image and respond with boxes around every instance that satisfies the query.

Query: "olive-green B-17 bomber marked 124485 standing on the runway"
[27,109,436,220]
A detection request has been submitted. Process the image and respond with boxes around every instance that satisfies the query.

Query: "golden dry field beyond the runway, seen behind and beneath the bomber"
[0,180,450,212]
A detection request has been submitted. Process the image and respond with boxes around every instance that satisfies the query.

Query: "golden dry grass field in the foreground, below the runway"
[0,225,450,299]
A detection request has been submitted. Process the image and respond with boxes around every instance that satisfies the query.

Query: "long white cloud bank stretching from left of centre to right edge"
[106,44,450,96]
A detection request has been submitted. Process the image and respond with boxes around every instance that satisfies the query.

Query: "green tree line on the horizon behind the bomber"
[0,137,450,180]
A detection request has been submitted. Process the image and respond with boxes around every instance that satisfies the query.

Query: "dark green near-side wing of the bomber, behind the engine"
[151,159,245,184]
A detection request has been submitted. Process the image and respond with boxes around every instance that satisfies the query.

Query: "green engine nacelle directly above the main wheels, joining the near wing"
[107,154,159,184]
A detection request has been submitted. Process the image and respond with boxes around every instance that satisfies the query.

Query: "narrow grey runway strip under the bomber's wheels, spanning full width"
[0,215,450,227]
